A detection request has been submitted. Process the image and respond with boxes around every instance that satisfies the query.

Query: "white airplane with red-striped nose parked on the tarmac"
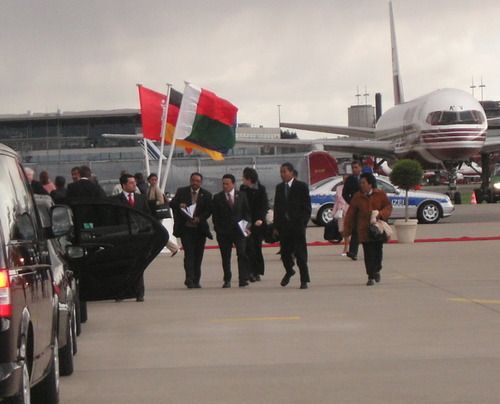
[238,2,500,187]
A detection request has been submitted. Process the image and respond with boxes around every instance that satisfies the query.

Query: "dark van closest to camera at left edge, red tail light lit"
[0,145,59,404]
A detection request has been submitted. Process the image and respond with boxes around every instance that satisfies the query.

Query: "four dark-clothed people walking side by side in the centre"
[170,163,311,289]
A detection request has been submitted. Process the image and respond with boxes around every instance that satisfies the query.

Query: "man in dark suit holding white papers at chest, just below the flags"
[170,173,212,289]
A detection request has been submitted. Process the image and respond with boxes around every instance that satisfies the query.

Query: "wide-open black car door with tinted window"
[67,200,168,301]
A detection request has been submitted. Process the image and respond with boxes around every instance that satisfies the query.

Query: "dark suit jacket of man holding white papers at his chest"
[170,186,212,238]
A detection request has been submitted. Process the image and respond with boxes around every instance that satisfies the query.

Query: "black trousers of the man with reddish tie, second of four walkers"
[217,232,249,283]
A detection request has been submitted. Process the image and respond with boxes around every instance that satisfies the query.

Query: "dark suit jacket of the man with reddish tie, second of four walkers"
[212,190,252,238]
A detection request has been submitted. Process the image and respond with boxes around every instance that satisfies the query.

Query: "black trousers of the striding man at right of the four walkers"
[280,227,311,283]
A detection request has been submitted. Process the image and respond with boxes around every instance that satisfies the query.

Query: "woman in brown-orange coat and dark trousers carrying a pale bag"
[344,173,392,286]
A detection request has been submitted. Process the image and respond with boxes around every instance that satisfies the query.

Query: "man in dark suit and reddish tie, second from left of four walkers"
[212,174,251,288]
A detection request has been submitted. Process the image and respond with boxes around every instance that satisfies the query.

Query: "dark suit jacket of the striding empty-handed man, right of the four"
[274,180,311,231]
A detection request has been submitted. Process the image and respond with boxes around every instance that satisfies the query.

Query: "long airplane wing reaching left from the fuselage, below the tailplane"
[236,138,395,158]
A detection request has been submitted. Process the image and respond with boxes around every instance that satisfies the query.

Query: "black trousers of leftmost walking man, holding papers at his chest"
[181,227,207,285]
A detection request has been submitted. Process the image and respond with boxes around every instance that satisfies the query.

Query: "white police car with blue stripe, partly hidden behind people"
[310,176,455,226]
